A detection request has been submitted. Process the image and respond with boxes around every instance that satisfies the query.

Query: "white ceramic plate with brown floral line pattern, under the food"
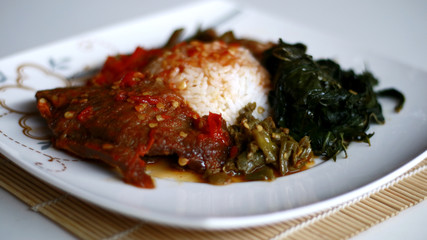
[0,2,427,229]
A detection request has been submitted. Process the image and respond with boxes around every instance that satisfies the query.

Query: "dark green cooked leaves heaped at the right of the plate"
[263,40,404,159]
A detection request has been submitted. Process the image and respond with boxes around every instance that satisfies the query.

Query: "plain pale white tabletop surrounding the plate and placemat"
[0,0,427,239]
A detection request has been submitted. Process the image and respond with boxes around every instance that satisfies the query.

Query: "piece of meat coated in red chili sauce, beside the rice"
[36,71,231,188]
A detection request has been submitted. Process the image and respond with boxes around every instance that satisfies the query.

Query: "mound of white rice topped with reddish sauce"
[147,41,270,124]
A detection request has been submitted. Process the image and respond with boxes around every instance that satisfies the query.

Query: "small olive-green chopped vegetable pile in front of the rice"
[224,103,313,180]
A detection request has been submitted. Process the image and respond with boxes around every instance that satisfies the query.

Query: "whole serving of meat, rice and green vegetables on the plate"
[36,29,403,188]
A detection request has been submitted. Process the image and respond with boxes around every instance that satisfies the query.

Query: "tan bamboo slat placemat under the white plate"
[0,155,427,240]
